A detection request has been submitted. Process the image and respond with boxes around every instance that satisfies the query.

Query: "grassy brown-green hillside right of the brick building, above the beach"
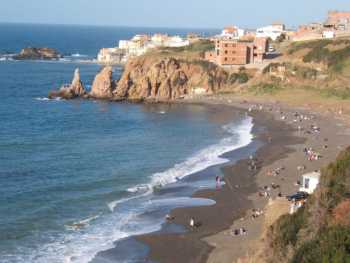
[249,39,350,99]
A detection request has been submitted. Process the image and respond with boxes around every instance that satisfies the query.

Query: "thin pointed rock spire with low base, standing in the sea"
[49,68,86,99]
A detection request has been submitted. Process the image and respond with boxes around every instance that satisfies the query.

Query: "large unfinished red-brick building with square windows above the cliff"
[205,38,268,66]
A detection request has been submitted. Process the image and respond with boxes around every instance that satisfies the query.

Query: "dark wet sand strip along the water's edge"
[136,108,304,263]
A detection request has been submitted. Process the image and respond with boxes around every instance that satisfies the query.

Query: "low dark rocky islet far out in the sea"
[13,47,62,60]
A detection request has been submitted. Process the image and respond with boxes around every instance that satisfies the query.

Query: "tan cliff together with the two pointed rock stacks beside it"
[50,56,230,102]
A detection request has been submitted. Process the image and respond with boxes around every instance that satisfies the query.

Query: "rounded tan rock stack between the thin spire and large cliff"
[89,66,116,99]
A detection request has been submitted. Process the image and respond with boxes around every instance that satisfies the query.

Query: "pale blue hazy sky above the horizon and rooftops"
[0,0,350,28]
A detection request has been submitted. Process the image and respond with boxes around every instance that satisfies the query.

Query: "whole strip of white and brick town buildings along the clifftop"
[97,11,350,67]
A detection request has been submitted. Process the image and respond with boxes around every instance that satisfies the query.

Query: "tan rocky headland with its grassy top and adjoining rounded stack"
[49,41,250,102]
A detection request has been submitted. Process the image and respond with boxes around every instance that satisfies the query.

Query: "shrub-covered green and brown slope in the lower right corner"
[269,148,350,263]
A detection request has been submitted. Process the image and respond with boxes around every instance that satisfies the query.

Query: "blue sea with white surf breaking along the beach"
[0,24,254,263]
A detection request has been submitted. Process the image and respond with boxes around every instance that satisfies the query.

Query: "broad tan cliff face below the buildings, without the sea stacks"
[114,57,228,101]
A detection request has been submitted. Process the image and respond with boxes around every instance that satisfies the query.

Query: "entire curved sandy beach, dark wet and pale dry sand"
[137,96,350,263]
